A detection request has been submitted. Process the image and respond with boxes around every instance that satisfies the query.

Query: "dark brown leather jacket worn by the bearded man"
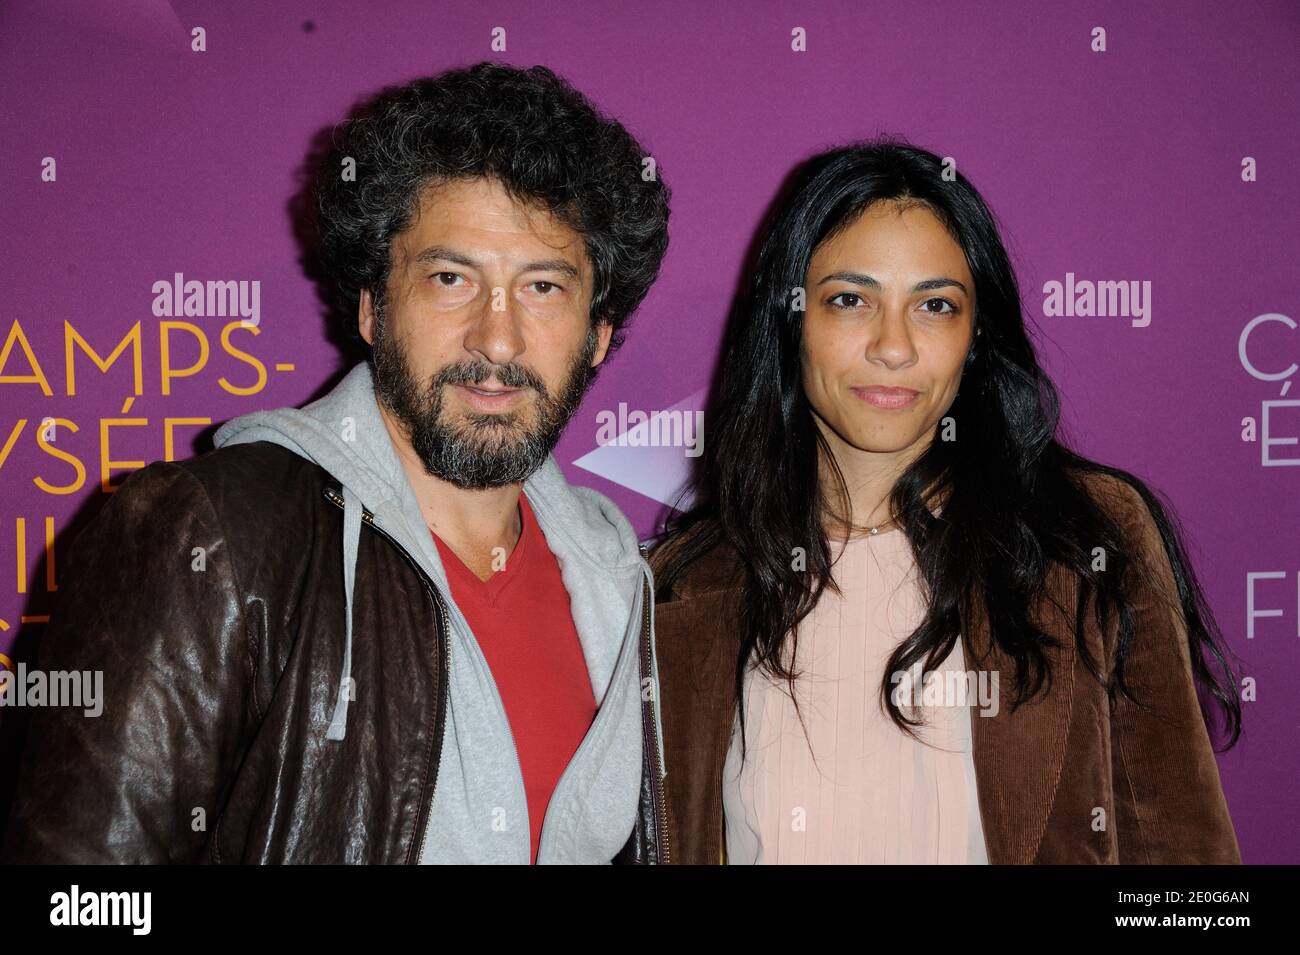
[0,442,663,863]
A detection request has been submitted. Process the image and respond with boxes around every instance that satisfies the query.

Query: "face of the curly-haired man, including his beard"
[359,179,612,489]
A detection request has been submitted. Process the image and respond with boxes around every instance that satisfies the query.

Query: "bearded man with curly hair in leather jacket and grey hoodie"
[4,64,670,863]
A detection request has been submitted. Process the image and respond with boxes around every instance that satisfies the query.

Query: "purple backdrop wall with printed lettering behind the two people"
[0,0,1300,863]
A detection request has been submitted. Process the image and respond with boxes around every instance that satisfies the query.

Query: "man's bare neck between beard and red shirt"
[380,401,524,579]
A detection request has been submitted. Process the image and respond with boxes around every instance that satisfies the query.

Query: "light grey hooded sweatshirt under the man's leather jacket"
[216,361,667,864]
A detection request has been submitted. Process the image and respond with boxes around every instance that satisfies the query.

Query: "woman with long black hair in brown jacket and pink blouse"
[651,142,1240,863]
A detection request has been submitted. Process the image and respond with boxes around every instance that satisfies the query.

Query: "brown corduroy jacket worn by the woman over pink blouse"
[651,477,1242,864]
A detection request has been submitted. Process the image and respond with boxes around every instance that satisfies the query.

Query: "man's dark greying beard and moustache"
[372,303,597,490]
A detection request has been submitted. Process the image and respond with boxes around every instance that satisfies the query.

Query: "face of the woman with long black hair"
[802,201,975,461]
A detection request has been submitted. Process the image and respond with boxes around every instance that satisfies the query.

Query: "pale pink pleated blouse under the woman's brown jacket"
[723,529,988,864]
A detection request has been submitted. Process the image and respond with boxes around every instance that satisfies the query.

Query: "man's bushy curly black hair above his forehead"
[313,62,671,353]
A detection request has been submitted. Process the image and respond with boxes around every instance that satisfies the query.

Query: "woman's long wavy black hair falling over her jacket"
[651,140,1242,752]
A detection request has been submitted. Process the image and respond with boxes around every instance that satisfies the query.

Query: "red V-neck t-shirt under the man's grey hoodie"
[433,494,595,863]
